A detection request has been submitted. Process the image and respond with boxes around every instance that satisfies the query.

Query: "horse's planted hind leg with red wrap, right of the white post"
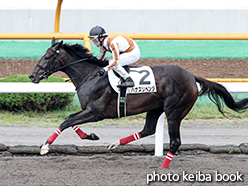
[160,91,197,168]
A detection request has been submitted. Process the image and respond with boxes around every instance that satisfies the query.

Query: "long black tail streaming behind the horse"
[195,77,248,115]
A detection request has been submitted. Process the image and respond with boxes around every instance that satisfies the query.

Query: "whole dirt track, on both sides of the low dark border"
[0,120,248,186]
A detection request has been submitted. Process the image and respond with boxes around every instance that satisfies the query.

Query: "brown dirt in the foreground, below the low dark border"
[0,154,248,186]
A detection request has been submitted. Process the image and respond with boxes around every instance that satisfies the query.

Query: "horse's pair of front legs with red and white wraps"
[40,109,99,155]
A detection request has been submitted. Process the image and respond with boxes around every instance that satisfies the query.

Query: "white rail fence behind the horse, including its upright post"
[0,82,248,156]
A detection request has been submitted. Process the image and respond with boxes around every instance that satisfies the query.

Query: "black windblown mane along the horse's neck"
[60,43,108,67]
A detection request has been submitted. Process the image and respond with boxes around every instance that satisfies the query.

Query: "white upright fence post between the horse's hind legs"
[155,112,165,156]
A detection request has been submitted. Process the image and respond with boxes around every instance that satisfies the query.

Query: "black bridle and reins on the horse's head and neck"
[36,48,97,90]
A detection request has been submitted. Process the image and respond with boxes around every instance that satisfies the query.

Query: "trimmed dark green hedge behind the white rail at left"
[0,75,74,111]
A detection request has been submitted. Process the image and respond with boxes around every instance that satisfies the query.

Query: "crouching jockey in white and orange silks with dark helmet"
[89,26,140,87]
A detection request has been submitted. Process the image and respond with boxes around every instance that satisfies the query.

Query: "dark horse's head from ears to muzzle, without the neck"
[29,38,63,83]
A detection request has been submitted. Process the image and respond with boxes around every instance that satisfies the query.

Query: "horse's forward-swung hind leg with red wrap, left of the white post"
[108,107,164,150]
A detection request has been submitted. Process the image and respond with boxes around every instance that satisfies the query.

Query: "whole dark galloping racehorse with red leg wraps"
[29,40,248,168]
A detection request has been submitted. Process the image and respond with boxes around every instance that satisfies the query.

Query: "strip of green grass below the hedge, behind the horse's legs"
[0,104,248,127]
